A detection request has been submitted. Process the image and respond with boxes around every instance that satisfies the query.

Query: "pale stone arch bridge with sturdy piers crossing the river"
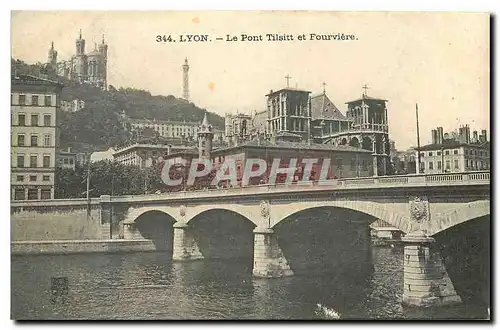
[13,172,490,305]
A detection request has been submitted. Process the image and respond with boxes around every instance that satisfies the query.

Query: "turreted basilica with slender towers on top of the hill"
[48,30,108,89]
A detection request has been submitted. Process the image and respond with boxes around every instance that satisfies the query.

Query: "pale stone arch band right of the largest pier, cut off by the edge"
[429,200,491,236]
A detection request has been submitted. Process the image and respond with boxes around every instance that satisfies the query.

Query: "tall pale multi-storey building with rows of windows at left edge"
[11,75,63,200]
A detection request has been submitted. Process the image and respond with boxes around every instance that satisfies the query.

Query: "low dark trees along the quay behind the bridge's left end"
[56,160,164,198]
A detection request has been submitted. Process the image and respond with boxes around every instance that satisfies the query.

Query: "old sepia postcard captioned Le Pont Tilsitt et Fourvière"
[10,11,492,321]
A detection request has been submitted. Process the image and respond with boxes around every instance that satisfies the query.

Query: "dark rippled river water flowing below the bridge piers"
[11,247,487,320]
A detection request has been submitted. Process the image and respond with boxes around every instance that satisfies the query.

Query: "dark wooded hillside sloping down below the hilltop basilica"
[11,59,224,151]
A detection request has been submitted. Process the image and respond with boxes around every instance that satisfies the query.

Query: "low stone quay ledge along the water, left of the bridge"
[10,239,157,255]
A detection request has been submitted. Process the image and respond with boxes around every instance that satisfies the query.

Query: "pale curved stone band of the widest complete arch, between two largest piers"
[271,201,412,233]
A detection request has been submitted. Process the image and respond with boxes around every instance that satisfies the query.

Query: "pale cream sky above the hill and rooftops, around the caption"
[12,11,490,150]
